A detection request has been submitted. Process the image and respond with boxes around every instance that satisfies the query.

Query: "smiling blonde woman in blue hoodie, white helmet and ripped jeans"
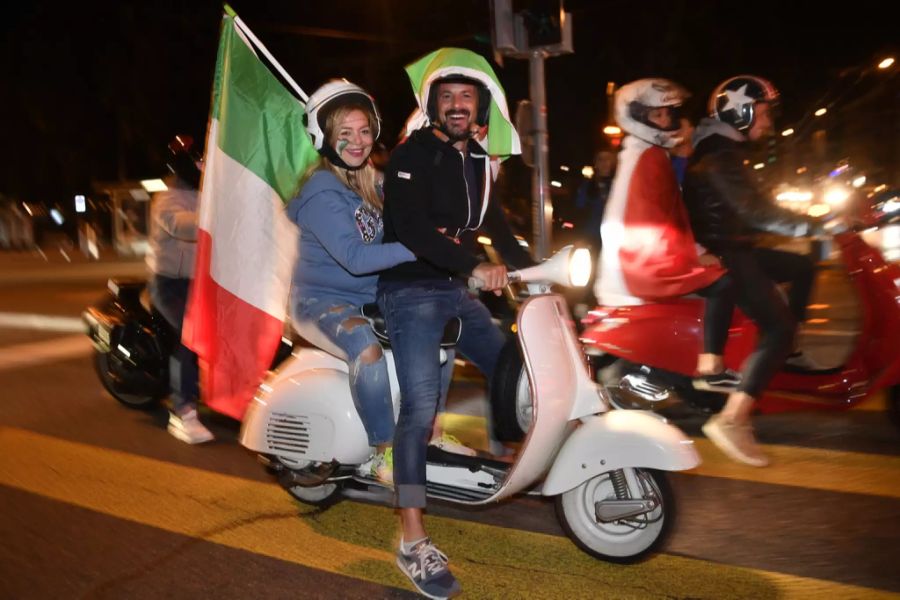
[287,79,415,482]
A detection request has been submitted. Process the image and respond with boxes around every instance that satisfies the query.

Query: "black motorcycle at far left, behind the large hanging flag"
[81,279,293,410]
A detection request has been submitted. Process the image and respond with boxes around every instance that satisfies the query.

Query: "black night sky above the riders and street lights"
[0,0,900,203]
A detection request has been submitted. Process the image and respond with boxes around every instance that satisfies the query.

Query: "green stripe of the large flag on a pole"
[211,15,318,202]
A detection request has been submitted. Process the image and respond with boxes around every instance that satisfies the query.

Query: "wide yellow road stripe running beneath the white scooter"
[0,427,897,600]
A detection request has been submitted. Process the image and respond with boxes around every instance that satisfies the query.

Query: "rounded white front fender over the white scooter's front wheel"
[541,410,700,496]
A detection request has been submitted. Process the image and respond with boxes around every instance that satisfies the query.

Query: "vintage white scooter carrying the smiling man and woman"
[240,247,700,562]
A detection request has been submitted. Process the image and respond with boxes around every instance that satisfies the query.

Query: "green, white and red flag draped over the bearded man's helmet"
[406,48,522,159]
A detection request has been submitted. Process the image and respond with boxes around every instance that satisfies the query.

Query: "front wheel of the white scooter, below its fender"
[556,469,675,564]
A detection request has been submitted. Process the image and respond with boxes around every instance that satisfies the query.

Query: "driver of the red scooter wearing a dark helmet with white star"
[684,75,822,467]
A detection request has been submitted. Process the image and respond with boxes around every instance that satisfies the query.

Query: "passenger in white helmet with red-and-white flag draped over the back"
[594,79,740,392]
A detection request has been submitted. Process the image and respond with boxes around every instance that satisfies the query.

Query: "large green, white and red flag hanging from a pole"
[182,6,317,419]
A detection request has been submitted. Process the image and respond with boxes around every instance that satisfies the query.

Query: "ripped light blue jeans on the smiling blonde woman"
[292,298,394,446]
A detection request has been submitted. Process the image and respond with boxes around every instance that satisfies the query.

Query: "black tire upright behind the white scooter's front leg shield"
[491,338,533,442]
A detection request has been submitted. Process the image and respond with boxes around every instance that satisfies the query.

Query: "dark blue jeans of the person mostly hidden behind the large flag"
[149,275,200,415]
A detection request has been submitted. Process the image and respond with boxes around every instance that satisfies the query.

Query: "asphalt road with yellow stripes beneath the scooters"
[0,250,900,599]
